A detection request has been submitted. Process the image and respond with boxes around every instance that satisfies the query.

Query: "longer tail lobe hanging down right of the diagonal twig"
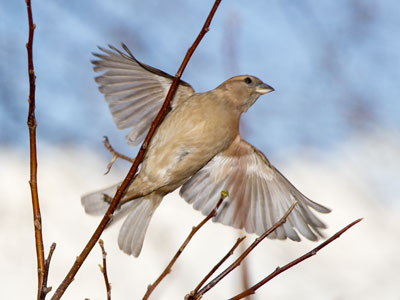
[118,194,162,257]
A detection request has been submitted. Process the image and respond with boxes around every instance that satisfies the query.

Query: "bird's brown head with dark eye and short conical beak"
[217,75,274,112]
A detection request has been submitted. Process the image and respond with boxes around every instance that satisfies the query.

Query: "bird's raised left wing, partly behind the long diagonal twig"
[92,44,194,146]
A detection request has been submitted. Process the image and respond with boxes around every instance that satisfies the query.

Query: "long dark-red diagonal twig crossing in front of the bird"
[51,0,221,300]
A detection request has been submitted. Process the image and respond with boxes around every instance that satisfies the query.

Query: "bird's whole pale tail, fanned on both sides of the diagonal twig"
[81,183,163,257]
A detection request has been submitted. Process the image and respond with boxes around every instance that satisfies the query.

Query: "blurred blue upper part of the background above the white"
[0,0,400,155]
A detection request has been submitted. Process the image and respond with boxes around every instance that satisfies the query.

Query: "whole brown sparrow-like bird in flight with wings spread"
[81,44,330,257]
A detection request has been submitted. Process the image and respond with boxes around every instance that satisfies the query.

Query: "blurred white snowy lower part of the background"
[0,131,400,300]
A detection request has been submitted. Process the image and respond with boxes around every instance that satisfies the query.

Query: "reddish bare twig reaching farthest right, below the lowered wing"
[229,218,362,300]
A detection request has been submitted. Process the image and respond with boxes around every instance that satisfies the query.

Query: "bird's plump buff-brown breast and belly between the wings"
[141,92,239,189]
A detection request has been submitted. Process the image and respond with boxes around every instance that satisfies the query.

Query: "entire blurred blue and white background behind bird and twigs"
[0,0,400,299]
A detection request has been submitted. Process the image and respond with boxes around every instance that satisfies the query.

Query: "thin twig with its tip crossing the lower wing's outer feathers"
[193,201,297,300]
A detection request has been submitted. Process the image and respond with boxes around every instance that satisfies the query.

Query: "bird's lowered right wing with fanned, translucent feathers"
[180,136,330,241]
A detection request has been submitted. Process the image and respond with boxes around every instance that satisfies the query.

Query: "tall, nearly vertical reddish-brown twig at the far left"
[25,0,45,299]
